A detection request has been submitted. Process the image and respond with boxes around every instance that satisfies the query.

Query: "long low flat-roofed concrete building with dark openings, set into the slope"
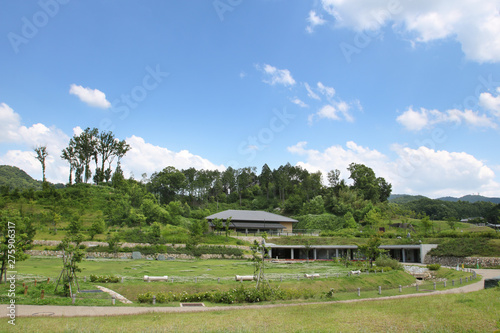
[266,243,437,263]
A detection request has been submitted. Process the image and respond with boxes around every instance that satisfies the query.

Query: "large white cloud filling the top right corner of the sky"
[322,0,500,62]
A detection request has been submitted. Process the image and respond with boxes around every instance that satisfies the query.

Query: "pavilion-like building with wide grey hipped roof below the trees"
[206,210,298,234]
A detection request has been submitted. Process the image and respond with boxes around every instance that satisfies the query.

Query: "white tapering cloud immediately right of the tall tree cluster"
[121,135,225,177]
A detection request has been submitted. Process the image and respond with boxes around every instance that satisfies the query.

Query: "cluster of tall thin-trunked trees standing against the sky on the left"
[61,127,131,185]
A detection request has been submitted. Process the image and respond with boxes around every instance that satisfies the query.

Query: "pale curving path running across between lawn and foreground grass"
[4,269,500,317]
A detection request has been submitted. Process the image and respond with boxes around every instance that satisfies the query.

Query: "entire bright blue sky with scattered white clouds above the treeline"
[0,0,500,197]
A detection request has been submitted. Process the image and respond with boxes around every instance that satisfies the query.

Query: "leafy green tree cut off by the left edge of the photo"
[0,210,36,283]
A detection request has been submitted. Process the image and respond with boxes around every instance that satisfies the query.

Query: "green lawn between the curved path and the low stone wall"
[4,257,480,306]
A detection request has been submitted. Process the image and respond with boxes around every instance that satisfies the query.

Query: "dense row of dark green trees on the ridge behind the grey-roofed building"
[146,163,391,209]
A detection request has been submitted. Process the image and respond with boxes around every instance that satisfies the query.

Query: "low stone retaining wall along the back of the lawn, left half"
[26,250,252,260]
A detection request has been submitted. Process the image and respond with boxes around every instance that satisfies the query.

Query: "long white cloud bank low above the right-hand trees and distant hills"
[288,141,500,198]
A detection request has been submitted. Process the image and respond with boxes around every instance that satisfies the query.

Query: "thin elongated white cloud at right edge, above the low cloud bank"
[396,107,497,131]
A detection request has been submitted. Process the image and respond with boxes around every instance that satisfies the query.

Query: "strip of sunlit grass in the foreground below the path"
[15,288,500,332]
